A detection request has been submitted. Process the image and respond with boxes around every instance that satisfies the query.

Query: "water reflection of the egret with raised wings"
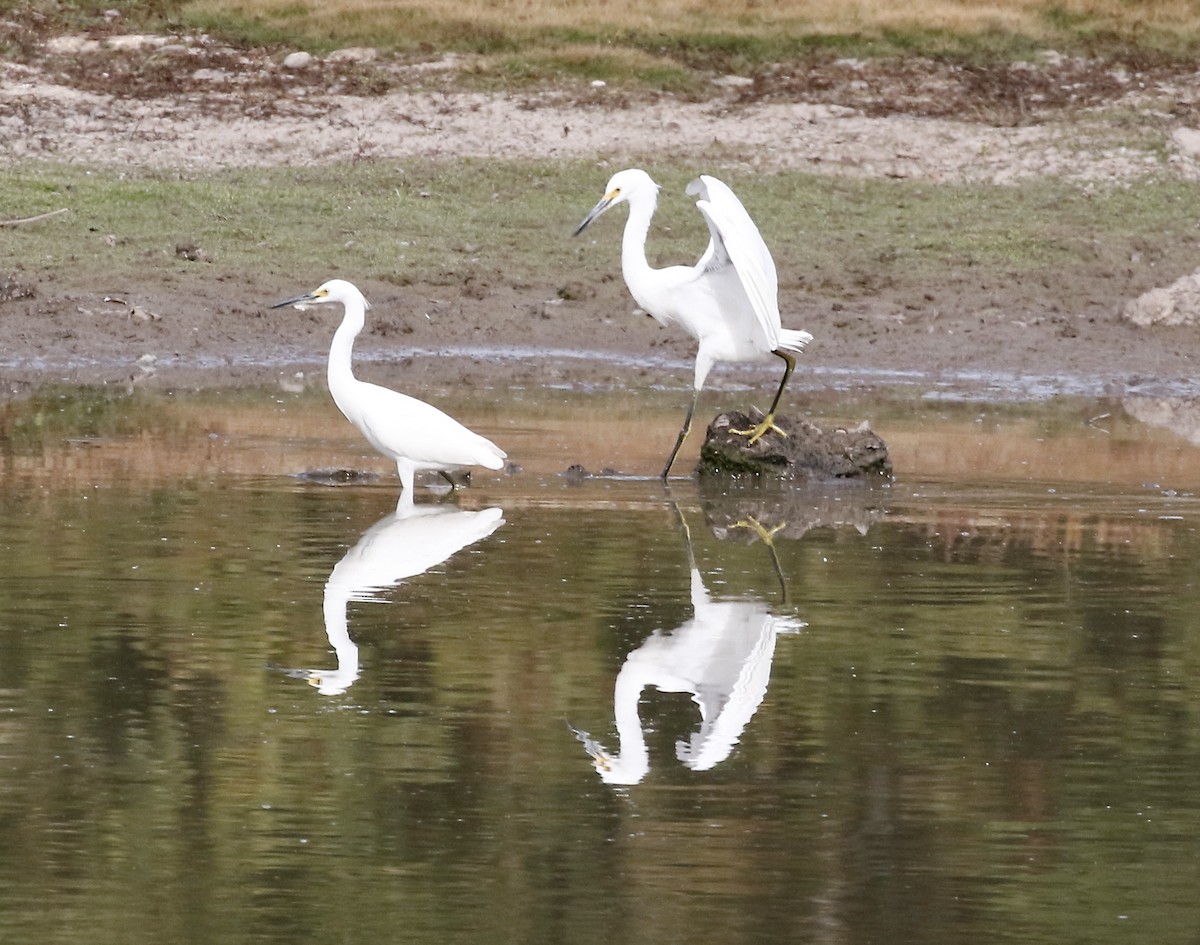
[575,514,805,784]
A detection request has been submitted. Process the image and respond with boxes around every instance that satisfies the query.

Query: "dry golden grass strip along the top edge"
[179,0,1200,90]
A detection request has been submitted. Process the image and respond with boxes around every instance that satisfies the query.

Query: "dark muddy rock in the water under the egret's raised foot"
[697,413,892,481]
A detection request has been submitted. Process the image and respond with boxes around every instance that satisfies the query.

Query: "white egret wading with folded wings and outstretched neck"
[271,279,506,501]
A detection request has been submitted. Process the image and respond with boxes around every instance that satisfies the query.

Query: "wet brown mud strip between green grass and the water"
[0,275,1200,401]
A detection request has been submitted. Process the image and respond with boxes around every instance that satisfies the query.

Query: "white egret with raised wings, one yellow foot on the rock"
[575,168,812,478]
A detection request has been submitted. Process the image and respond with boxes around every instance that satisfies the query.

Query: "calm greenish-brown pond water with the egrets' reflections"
[0,393,1200,945]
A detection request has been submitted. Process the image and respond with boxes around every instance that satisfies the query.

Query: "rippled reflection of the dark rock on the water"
[700,480,889,542]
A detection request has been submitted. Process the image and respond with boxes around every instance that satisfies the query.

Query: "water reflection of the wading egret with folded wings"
[288,501,504,696]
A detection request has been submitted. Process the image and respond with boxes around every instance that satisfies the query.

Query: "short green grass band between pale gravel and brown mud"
[7,161,1200,302]
